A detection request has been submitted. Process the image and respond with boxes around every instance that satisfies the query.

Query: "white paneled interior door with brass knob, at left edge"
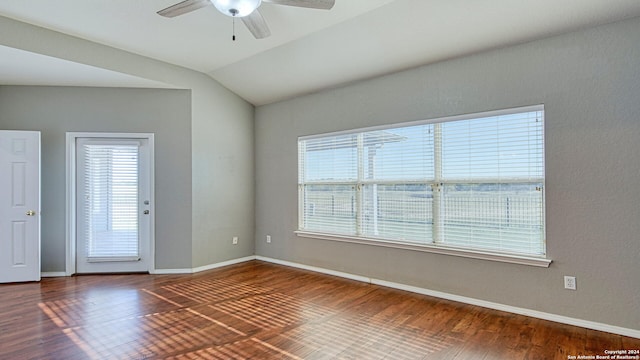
[0,131,40,283]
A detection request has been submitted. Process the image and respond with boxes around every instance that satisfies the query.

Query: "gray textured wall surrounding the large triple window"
[255,19,640,329]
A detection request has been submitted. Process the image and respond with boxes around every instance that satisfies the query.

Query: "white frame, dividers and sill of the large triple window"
[295,105,551,267]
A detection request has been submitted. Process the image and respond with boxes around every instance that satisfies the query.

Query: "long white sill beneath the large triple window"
[295,230,551,267]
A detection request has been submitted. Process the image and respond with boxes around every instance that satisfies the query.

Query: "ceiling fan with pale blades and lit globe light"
[158,0,335,40]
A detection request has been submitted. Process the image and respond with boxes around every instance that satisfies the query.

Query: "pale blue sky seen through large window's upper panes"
[301,111,544,182]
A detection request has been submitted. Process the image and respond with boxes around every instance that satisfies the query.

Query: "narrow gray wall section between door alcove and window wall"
[191,80,255,268]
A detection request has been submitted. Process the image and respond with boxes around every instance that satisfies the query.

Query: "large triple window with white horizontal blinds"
[298,106,545,257]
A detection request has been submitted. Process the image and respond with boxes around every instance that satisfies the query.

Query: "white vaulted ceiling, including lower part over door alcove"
[0,0,640,105]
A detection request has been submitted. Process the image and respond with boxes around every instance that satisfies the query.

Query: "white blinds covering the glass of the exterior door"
[80,144,139,261]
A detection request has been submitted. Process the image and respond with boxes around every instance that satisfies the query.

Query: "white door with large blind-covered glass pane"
[76,138,151,273]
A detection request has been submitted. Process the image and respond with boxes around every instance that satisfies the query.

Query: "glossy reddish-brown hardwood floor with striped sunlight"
[0,261,640,360]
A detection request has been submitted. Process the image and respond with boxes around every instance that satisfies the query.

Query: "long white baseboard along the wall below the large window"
[255,256,640,339]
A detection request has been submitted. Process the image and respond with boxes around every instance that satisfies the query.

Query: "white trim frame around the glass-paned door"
[65,132,156,276]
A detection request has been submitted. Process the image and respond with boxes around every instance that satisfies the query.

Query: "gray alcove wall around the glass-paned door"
[0,86,191,272]
